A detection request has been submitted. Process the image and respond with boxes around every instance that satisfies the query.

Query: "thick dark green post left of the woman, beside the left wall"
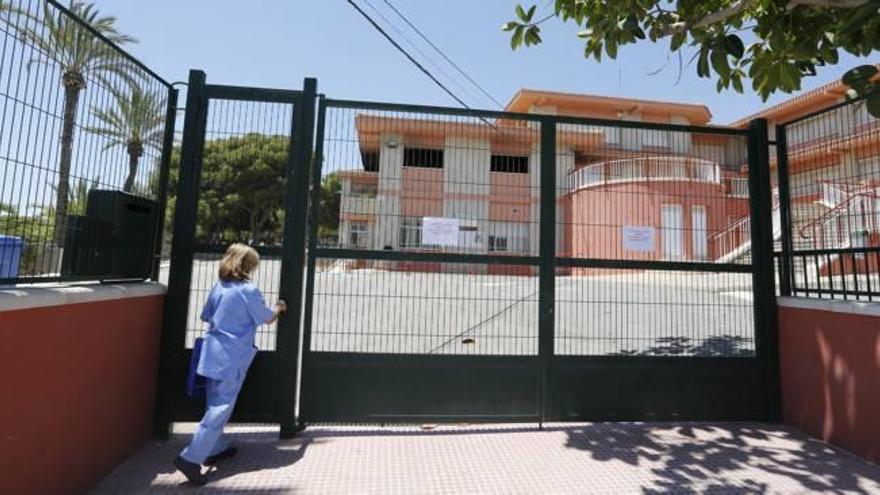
[153,70,208,438]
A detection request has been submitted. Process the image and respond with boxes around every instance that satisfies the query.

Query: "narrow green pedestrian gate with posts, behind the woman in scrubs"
[155,71,316,436]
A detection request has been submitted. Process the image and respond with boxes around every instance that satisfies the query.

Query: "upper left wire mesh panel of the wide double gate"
[321,106,540,260]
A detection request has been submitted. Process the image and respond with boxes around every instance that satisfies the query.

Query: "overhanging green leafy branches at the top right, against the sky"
[502,0,880,117]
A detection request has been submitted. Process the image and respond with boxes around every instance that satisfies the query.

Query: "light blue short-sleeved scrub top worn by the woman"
[197,281,275,380]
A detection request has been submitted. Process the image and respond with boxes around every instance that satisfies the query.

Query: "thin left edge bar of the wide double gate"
[299,96,327,422]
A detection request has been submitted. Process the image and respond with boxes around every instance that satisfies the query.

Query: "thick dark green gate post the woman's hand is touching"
[276,78,318,438]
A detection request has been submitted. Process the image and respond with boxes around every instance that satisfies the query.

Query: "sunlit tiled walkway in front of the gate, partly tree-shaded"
[94,423,880,495]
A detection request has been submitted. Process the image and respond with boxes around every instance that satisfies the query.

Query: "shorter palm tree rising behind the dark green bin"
[86,86,165,192]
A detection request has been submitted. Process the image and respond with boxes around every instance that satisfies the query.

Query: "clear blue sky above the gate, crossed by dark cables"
[96,0,880,124]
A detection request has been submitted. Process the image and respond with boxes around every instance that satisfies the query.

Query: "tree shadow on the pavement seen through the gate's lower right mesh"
[614,335,755,357]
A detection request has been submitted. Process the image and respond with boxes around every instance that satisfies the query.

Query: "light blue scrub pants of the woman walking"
[180,373,244,464]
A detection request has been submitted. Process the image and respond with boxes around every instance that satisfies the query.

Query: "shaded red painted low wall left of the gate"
[0,295,164,495]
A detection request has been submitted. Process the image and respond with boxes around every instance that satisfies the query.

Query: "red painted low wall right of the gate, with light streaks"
[779,307,880,463]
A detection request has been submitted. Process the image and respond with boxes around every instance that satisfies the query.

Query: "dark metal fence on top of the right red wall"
[776,91,880,301]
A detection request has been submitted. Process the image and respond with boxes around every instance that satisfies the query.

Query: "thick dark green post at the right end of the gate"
[748,119,781,421]
